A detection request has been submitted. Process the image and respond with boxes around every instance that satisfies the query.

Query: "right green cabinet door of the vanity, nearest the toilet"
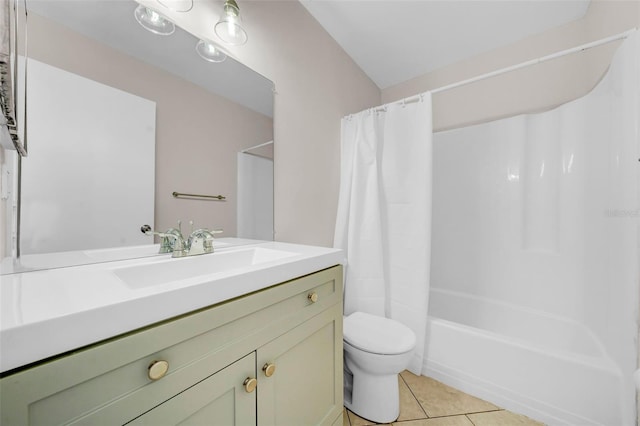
[257,304,342,426]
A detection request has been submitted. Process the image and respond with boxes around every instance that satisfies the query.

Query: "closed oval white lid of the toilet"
[343,312,416,355]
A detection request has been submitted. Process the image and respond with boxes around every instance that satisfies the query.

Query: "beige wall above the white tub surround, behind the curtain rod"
[382,0,640,131]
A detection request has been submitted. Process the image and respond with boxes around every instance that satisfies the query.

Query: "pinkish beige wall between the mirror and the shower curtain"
[140,0,380,246]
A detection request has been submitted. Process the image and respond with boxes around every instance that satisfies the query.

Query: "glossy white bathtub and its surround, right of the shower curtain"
[425,31,640,425]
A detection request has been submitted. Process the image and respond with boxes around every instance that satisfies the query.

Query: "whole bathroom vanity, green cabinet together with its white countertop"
[0,243,342,425]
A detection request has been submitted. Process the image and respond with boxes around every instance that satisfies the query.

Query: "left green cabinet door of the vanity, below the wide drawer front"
[127,352,256,426]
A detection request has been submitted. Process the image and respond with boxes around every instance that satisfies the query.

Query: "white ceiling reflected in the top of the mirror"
[27,0,273,117]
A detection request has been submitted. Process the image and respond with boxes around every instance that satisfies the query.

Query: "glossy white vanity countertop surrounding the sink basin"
[0,239,343,372]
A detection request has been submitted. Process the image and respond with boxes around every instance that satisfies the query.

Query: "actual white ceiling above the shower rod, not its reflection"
[300,0,589,89]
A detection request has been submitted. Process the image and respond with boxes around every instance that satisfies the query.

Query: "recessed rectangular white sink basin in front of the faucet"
[113,247,297,289]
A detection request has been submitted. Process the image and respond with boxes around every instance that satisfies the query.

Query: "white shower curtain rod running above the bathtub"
[375,27,638,111]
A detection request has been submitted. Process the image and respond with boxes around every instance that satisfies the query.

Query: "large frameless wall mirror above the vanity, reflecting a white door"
[1,0,273,274]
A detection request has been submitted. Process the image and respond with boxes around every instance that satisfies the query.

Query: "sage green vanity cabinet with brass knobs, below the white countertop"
[0,266,343,426]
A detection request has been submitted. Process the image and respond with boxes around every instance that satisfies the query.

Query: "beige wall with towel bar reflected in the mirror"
[29,14,273,236]
